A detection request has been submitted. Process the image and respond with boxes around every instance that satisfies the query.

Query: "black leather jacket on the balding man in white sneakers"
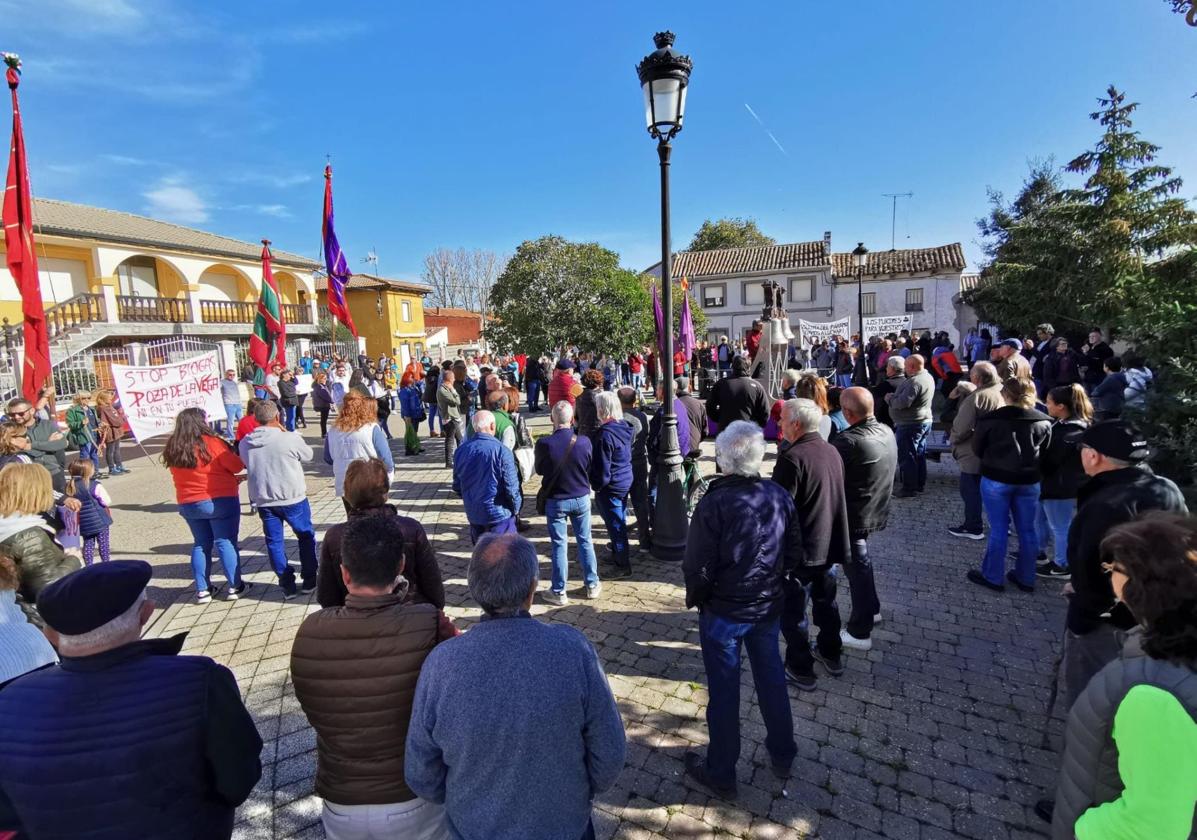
[831,416,898,535]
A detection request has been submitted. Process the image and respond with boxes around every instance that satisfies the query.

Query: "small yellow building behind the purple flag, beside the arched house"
[316,274,432,366]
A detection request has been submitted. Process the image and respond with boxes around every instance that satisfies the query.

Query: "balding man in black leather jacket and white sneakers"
[832,388,898,651]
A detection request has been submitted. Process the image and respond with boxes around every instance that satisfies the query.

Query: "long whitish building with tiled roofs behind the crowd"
[648,232,966,341]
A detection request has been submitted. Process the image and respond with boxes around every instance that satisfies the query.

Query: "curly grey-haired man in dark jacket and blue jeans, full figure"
[682,421,802,798]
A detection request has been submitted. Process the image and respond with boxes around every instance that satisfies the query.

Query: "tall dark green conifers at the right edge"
[966,87,1197,488]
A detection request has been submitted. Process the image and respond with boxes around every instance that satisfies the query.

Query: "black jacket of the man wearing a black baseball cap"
[1068,464,1189,633]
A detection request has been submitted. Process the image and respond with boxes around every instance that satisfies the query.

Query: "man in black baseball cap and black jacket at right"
[1061,420,1187,711]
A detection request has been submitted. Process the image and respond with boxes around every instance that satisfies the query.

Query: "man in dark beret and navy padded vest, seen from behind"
[0,560,262,840]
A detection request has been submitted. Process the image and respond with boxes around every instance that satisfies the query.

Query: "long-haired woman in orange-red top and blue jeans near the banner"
[162,408,249,603]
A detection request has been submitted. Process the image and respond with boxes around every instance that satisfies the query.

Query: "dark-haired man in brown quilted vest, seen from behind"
[291,516,456,839]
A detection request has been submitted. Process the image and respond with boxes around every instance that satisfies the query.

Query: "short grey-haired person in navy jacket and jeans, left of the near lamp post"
[590,391,634,578]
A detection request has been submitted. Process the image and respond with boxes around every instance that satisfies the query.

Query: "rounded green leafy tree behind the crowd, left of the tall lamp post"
[485,236,652,354]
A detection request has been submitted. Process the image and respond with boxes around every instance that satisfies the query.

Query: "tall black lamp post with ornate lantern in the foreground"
[636,32,694,560]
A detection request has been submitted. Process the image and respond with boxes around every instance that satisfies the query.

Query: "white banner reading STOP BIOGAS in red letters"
[113,351,225,443]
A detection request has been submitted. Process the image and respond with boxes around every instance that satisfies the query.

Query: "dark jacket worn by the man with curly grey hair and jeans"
[682,475,802,622]
